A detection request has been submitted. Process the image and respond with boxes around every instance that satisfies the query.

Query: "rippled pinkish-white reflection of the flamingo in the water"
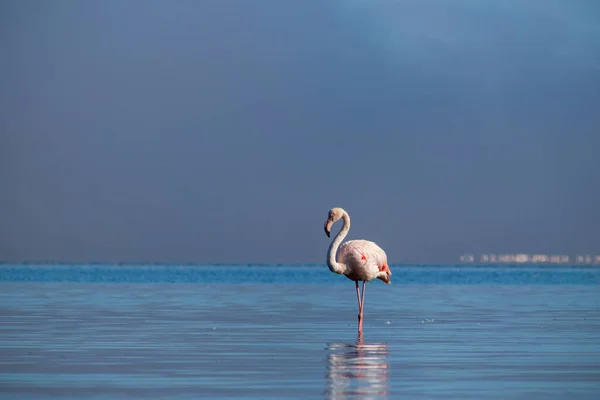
[325,333,389,399]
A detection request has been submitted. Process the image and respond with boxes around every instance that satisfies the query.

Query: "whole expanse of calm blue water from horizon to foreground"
[0,265,600,399]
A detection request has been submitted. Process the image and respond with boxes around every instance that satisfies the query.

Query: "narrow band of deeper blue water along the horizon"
[0,264,600,285]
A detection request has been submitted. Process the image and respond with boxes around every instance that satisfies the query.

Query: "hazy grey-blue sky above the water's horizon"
[0,0,600,264]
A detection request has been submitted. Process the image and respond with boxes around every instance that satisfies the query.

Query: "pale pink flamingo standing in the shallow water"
[325,207,392,333]
